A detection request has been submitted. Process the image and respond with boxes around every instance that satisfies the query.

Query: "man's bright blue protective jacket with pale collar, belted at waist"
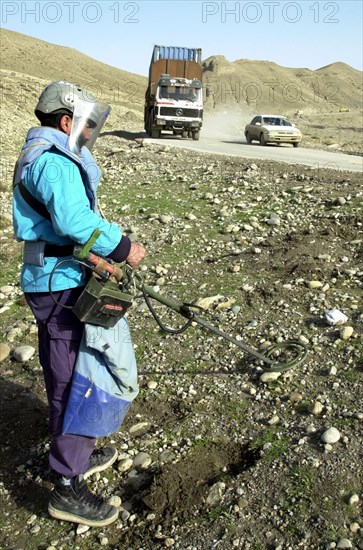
[13,127,122,292]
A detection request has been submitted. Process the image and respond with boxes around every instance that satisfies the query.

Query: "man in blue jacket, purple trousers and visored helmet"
[13,81,145,526]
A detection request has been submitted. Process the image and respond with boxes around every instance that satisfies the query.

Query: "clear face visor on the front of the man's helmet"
[69,99,111,153]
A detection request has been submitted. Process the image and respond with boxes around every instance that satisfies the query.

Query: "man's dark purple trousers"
[25,287,96,477]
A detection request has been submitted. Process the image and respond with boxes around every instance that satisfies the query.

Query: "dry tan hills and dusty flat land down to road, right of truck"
[203,55,363,153]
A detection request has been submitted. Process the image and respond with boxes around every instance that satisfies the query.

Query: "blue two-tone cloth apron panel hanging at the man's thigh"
[62,317,139,438]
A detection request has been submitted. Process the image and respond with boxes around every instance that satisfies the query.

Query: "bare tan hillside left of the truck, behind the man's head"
[0,29,147,173]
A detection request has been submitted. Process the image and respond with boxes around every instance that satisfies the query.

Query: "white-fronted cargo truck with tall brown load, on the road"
[144,46,203,140]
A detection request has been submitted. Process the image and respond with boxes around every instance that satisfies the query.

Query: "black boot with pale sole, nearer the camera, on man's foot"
[48,476,118,527]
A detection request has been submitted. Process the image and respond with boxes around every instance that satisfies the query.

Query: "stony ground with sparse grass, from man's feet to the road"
[0,134,363,550]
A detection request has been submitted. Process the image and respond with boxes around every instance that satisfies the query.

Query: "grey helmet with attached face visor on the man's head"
[35,80,111,153]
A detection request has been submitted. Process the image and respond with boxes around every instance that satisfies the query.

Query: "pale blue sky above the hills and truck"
[1,0,363,76]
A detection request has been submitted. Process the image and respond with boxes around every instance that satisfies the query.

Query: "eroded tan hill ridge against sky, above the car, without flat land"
[203,55,363,113]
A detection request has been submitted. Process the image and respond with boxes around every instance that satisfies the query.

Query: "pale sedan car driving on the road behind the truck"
[245,115,302,147]
